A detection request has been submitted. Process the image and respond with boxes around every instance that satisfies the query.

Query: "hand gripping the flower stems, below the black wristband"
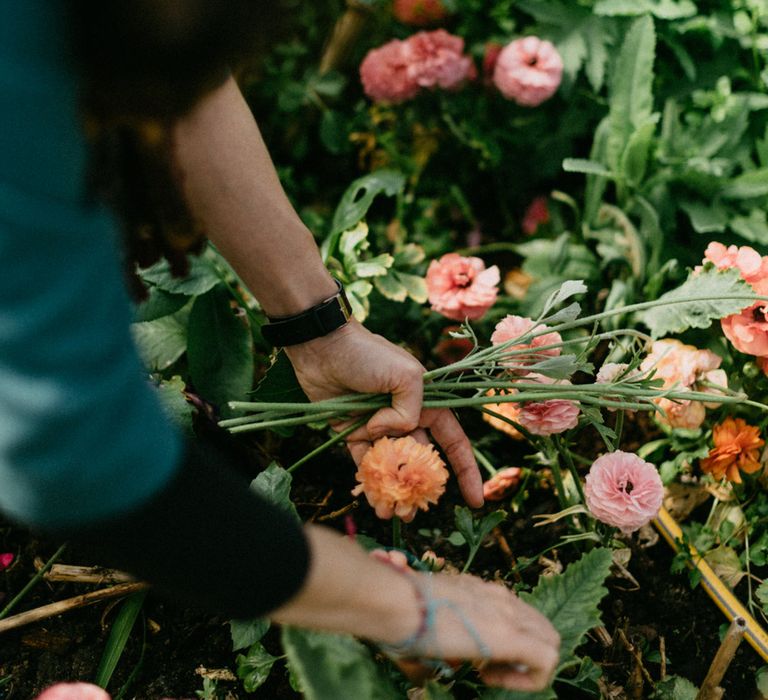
[286,320,483,508]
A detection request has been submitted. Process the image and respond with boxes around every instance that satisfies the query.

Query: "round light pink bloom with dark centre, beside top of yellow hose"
[584,450,664,535]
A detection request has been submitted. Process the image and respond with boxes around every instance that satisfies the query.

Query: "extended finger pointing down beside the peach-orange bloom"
[420,408,483,508]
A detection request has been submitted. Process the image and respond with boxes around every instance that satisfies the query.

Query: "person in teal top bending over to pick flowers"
[0,0,559,690]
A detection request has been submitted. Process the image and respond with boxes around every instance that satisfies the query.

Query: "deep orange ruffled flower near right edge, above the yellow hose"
[701,418,765,484]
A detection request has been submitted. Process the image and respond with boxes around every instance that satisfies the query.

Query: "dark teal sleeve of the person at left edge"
[0,0,181,528]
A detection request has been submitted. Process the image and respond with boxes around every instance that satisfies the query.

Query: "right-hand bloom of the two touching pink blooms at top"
[404,29,477,90]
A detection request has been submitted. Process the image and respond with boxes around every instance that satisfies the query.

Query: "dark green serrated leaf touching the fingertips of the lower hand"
[520,548,613,662]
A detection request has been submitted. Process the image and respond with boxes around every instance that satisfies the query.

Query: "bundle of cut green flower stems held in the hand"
[220,282,768,433]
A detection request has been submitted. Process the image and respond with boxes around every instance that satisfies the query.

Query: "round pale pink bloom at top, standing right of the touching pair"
[493,36,563,107]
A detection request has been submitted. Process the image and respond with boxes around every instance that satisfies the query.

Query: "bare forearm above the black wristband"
[174,78,336,316]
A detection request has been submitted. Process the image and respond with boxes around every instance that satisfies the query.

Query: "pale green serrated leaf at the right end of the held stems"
[641,267,754,338]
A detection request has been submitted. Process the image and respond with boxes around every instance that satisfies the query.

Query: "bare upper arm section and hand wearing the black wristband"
[174,79,483,506]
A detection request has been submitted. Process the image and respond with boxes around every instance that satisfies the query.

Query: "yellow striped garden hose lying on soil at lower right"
[653,508,768,661]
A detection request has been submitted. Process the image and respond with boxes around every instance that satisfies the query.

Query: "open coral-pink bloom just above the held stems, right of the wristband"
[426,253,501,321]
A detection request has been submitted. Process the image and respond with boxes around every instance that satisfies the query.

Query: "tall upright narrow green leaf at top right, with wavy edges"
[607,15,656,171]
